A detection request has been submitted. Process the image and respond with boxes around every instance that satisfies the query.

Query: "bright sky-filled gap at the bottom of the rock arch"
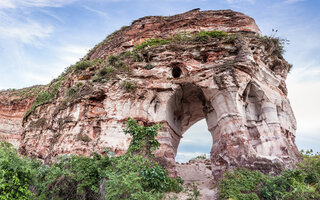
[175,119,212,163]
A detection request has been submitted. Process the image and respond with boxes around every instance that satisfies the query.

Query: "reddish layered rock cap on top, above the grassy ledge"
[88,9,261,60]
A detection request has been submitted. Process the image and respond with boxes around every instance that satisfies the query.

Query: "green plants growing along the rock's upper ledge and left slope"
[52,31,228,86]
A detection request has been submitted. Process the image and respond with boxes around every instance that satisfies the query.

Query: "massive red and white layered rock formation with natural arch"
[0,9,300,177]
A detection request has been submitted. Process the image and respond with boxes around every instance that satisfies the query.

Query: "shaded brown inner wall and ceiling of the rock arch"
[166,83,217,164]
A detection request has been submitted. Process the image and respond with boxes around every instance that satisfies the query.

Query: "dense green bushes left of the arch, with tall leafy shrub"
[0,119,182,200]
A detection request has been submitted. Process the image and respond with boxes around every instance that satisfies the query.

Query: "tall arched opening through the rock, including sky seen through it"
[167,83,217,163]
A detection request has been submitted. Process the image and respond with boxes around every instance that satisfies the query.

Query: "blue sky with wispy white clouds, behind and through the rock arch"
[0,0,320,162]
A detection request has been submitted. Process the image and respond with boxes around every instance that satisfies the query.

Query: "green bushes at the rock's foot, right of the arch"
[219,151,320,200]
